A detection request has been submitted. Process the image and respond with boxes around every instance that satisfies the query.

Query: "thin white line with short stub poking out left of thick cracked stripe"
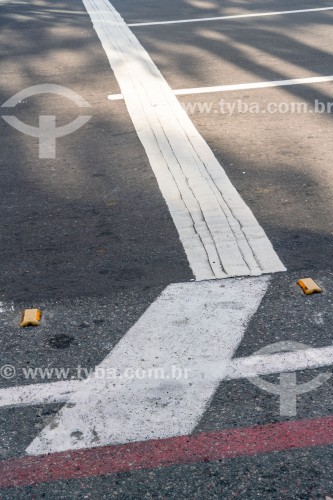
[108,75,333,101]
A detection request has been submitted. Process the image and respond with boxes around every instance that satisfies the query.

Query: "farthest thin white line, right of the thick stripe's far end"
[128,7,333,27]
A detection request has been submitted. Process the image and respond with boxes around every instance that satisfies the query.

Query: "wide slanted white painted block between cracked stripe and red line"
[27,276,269,455]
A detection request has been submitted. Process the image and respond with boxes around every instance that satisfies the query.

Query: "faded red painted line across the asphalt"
[0,416,333,488]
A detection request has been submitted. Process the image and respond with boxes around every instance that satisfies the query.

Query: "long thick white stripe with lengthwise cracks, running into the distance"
[83,0,285,280]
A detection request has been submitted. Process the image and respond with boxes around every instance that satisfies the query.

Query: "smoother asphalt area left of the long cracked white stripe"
[0,1,192,301]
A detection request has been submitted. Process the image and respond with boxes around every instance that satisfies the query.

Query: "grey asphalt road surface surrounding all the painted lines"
[0,0,333,499]
